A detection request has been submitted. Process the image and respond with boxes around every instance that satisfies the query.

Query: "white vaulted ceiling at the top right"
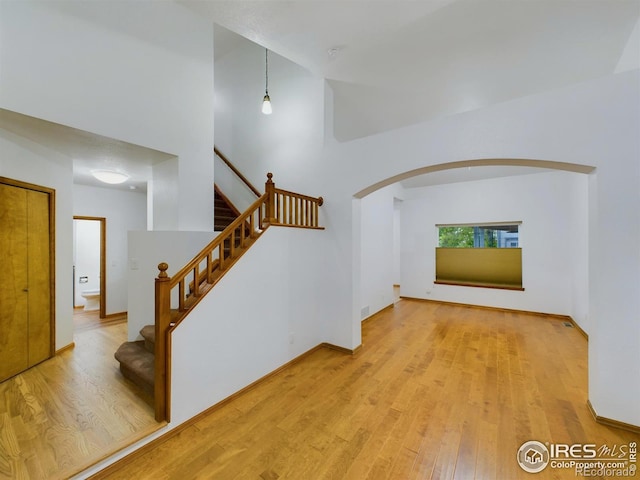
[185,0,640,140]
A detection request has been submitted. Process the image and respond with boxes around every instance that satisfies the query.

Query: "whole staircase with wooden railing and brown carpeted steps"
[114,167,323,422]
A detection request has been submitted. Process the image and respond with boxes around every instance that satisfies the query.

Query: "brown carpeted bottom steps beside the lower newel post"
[114,325,156,396]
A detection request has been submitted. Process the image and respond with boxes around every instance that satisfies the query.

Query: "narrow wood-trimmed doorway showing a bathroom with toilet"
[73,216,107,319]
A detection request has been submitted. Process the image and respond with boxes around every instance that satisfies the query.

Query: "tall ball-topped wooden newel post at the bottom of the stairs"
[153,262,171,422]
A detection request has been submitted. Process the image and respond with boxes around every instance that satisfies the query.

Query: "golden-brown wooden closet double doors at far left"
[0,179,53,381]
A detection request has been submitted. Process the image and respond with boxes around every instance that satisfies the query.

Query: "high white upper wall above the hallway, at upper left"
[0,1,213,230]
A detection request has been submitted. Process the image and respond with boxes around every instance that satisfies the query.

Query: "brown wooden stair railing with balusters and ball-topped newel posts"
[154,173,323,422]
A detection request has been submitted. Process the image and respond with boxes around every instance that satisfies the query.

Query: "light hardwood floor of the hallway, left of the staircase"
[0,313,160,480]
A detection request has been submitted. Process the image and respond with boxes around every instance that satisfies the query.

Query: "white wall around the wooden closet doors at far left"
[0,129,73,350]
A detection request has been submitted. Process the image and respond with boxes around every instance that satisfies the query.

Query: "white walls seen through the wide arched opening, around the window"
[353,159,595,330]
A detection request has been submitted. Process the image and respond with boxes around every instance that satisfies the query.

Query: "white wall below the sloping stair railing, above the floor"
[171,227,328,425]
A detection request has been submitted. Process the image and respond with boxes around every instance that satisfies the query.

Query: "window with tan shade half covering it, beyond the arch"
[435,222,524,290]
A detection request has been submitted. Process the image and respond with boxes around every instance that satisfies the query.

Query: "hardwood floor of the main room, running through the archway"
[93,299,640,480]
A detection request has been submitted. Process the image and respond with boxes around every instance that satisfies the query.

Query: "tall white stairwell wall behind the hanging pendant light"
[215,33,324,196]
